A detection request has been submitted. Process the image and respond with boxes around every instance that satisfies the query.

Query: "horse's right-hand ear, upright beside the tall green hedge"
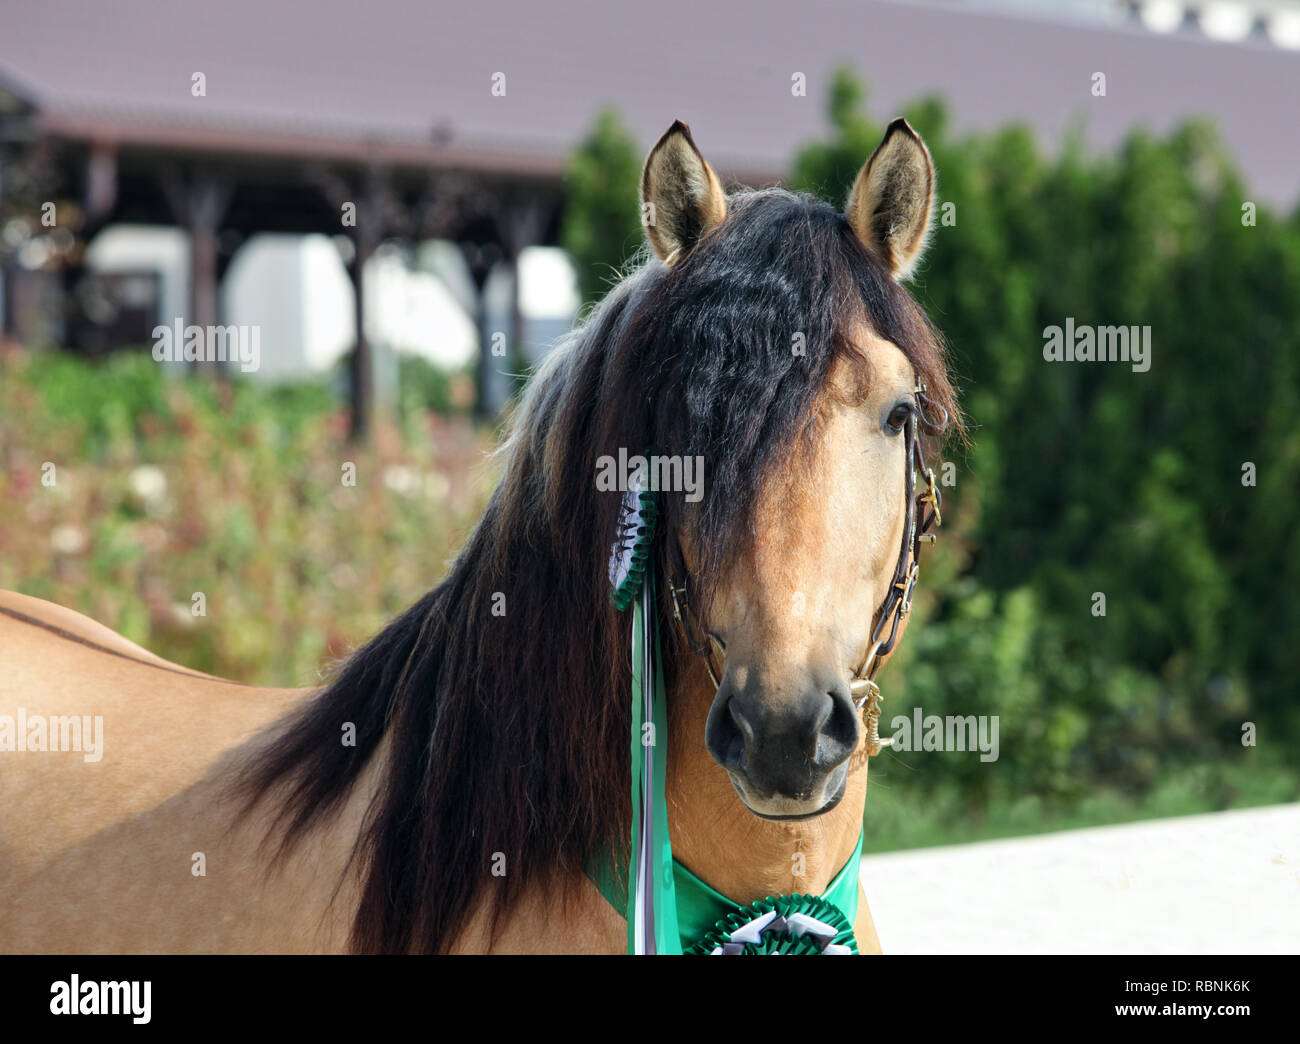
[844,117,935,280]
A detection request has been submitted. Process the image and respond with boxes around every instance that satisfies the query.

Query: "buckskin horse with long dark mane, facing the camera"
[0,120,961,954]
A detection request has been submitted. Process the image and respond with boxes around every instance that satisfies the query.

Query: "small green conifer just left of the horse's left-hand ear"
[560,109,642,303]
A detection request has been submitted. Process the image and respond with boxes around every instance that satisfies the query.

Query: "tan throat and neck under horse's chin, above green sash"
[668,666,867,904]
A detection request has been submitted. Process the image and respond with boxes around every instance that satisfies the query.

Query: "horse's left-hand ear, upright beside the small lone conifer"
[641,120,727,265]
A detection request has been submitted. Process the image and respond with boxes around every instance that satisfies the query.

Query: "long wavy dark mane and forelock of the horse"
[242,189,957,952]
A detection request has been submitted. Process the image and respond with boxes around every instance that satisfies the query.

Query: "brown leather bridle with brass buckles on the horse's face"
[668,381,948,757]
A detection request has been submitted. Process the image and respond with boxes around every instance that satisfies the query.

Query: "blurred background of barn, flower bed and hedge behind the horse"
[0,0,1300,858]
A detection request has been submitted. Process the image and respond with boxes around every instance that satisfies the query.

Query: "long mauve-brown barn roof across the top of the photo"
[0,0,1300,204]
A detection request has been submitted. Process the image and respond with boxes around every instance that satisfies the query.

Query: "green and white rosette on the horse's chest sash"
[685,893,858,957]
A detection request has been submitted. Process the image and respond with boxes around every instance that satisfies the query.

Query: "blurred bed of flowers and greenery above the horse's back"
[0,351,494,685]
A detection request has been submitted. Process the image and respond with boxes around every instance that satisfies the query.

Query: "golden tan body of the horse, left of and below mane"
[0,592,625,953]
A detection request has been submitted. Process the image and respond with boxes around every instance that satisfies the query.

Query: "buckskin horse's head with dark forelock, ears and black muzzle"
[641,120,950,819]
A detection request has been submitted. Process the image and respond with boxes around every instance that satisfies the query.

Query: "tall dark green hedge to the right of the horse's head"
[793,73,1300,842]
